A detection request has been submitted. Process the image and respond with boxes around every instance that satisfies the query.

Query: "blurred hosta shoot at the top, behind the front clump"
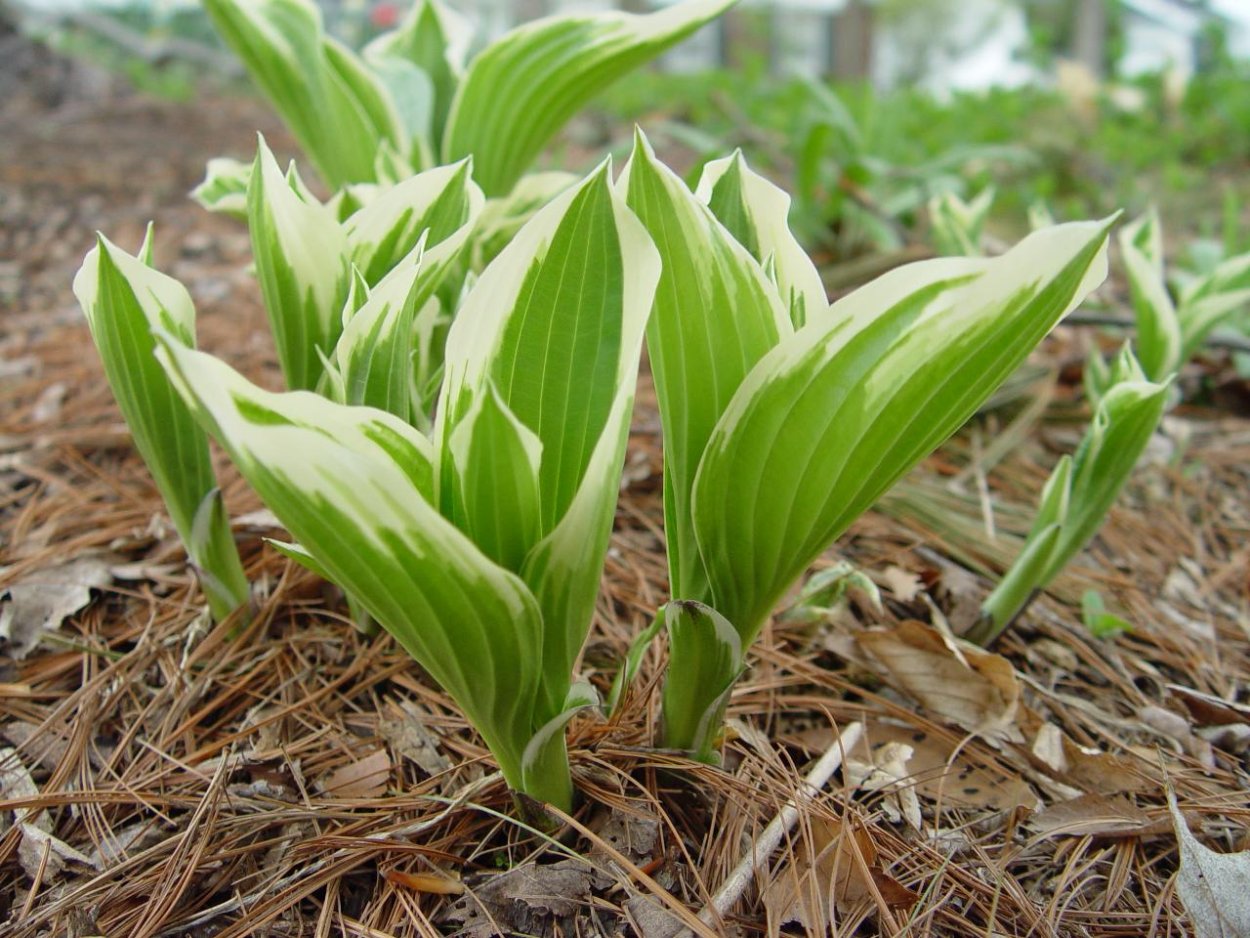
[205,0,734,196]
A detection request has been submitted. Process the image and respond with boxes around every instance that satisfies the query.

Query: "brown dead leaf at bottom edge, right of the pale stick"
[764,817,920,934]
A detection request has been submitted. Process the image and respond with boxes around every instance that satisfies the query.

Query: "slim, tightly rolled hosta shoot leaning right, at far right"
[968,346,1168,645]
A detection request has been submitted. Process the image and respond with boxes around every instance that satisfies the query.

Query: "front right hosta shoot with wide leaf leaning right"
[623,133,1108,758]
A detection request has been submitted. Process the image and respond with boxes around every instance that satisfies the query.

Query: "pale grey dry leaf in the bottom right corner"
[1168,789,1250,938]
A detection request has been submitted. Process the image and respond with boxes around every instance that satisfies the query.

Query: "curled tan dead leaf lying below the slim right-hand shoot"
[856,619,1024,743]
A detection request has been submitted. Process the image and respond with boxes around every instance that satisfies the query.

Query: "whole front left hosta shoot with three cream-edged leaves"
[151,166,660,809]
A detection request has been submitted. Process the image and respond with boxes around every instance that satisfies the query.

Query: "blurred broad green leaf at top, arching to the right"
[443,0,735,196]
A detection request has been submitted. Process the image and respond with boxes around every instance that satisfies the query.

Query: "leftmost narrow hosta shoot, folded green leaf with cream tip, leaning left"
[74,228,249,620]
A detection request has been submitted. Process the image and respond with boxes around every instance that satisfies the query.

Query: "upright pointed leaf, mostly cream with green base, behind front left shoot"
[248,139,350,390]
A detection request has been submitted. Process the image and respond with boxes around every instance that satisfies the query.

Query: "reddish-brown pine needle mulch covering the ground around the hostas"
[0,82,1250,938]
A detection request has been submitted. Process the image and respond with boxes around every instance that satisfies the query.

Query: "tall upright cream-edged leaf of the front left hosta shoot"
[435,164,660,712]
